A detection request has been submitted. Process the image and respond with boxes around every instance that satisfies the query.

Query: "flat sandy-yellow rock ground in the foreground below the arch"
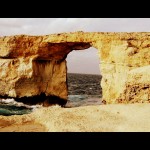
[0,104,150,132]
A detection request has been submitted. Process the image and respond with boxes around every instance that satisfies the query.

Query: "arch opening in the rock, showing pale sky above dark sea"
[66,47,102,107]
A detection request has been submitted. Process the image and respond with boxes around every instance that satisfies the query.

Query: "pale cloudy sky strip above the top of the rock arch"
[0,18,150,36]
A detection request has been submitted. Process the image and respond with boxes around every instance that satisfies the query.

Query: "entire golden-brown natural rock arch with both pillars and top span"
[0,32,150,104]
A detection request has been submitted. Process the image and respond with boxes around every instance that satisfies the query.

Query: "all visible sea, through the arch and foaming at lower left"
[0,73,102,116]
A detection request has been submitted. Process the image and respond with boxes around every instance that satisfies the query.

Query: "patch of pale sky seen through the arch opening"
[66,48,100,74]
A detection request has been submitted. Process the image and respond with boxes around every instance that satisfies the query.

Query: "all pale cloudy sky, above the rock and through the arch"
[0,18,150,74]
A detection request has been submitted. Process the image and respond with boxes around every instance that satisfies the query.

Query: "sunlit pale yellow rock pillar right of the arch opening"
[94,39,150,103]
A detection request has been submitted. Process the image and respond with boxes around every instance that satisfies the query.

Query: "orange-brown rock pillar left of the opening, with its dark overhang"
[0,36,90,105]
